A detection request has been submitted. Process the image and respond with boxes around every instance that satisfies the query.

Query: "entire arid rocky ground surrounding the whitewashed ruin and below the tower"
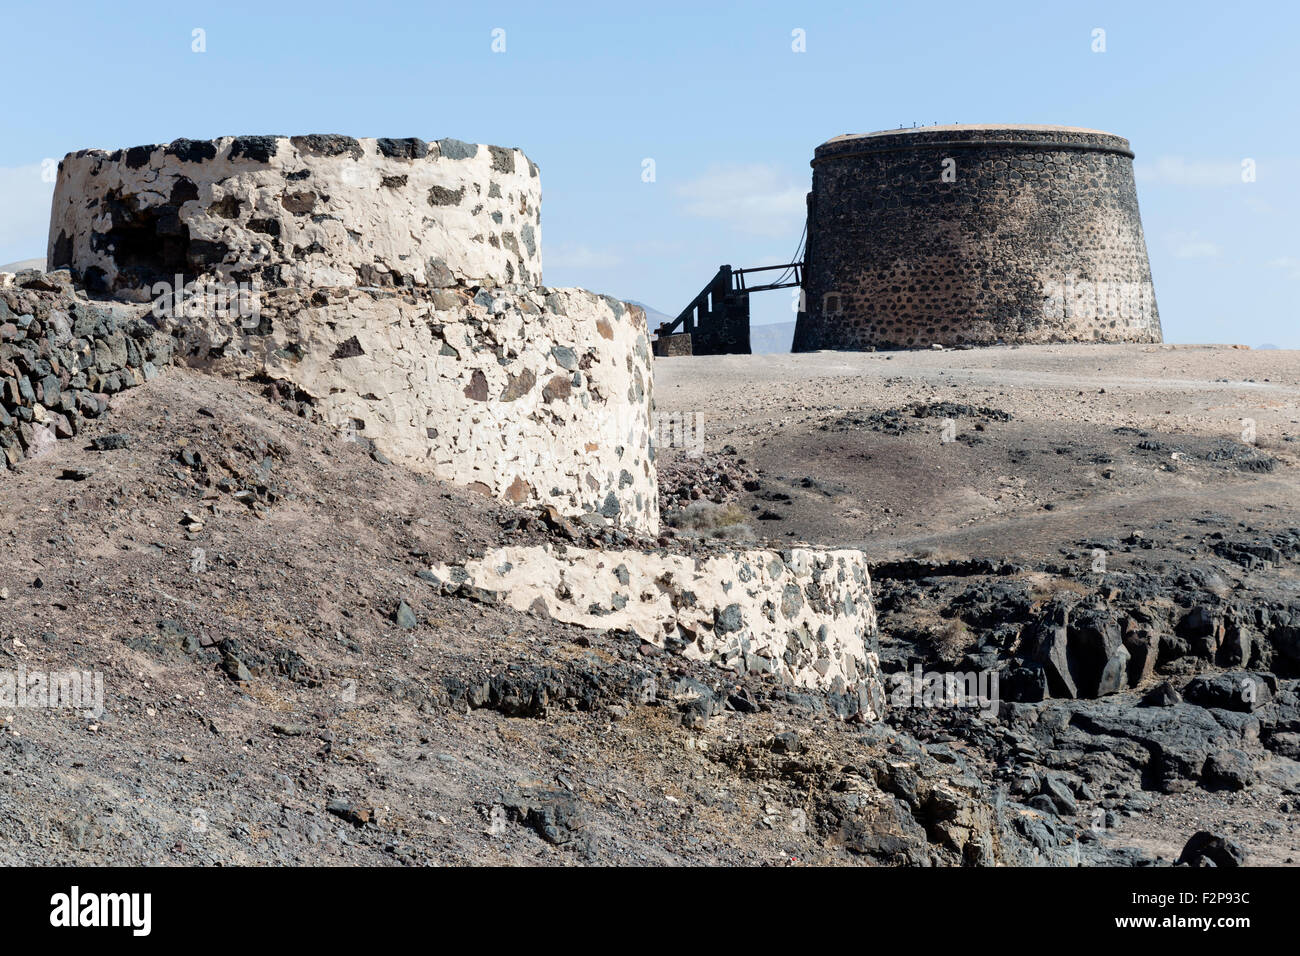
[0,346,1300,865]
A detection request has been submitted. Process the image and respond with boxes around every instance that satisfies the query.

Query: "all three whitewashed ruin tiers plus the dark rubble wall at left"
[15,137,884,721]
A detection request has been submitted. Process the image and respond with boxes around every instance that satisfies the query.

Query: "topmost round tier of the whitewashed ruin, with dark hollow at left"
[48,135,542,297]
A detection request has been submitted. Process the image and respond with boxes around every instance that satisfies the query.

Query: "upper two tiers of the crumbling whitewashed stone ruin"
[41,135,659,533]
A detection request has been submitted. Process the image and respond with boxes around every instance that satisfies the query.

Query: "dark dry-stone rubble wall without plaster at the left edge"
[0,271,172,468]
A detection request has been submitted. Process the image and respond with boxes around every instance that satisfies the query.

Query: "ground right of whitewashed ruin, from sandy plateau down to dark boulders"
[655,346,1300,864]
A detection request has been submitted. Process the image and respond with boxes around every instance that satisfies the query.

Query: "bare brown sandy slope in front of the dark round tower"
[655,345,1300,559]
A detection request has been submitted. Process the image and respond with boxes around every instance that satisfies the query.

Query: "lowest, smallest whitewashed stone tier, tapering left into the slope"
[432,546,884,719]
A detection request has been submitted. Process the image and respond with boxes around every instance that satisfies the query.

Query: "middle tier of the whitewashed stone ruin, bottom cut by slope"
[178,287,659,533]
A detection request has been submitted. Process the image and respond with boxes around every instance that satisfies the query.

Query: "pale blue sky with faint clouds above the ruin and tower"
[0,0,1300,347]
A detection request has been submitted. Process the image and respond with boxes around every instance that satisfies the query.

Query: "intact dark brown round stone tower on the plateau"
[794,125,1161,351]
